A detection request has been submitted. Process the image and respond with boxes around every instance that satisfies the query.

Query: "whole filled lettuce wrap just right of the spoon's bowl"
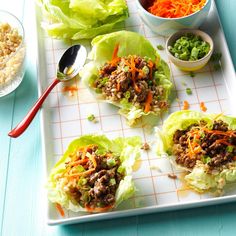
[80,31,173,125]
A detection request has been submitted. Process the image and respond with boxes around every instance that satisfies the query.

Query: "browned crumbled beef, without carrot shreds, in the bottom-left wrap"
[65,145,124,208]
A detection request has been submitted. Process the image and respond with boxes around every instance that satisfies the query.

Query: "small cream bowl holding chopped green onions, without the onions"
[166,30,214,71]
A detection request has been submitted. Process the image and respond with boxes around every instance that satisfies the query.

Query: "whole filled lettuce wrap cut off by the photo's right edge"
[157,111,236,193]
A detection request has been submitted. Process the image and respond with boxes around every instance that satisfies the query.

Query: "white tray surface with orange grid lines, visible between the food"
[40,0,230,217]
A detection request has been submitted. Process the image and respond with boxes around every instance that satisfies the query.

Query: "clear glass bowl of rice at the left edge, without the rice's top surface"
[0,10,26,97]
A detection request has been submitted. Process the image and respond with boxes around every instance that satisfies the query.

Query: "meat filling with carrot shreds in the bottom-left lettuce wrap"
[60,145,124,211]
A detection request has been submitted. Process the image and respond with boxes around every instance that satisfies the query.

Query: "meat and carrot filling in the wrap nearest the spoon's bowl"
[93,56,169,112]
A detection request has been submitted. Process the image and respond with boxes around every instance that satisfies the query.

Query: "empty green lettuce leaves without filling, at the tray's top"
[38,0,128,40]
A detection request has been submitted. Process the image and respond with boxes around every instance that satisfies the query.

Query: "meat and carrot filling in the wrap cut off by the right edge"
[173,120,236,169]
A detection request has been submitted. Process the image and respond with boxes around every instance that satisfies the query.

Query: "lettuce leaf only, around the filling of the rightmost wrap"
[156,110,236,192]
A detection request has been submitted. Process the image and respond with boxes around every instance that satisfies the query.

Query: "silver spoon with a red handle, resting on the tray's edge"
[8,45,87,138]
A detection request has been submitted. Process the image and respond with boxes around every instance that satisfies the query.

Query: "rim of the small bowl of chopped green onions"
[166,29,214,64]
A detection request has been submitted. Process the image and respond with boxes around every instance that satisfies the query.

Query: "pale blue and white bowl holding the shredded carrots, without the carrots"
[135,0,211,36]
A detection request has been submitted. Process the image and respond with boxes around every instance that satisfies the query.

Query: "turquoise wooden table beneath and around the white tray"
[0,0,236,236]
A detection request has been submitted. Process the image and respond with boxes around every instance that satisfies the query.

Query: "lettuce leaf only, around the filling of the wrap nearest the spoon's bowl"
[80,31,173,126]
